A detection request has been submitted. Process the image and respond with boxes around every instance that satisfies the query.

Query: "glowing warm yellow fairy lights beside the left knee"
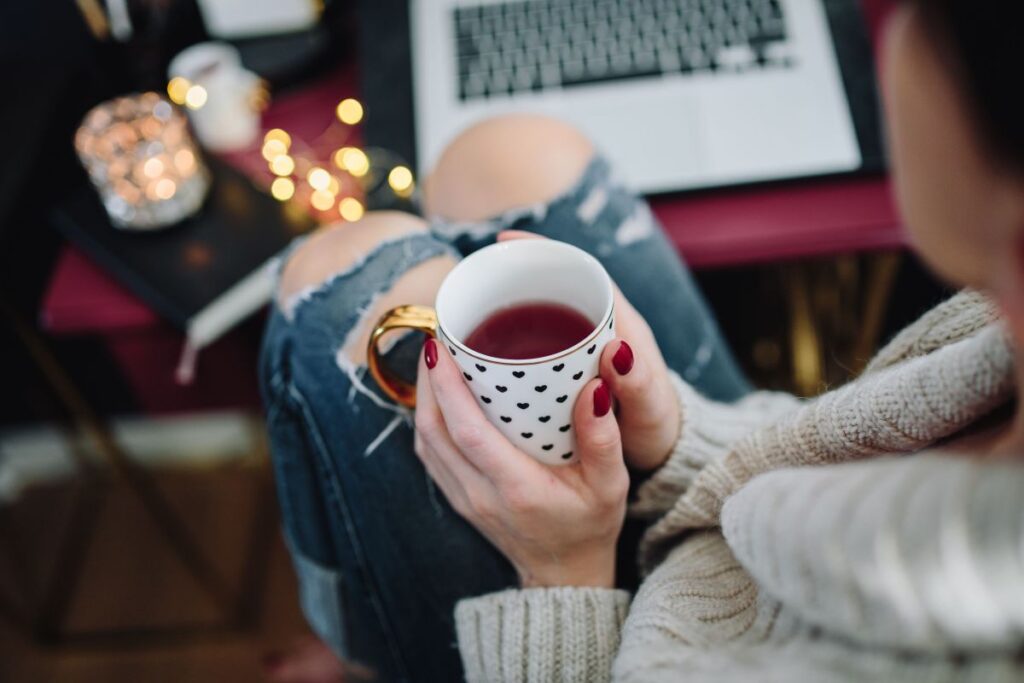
[167,77,416,221]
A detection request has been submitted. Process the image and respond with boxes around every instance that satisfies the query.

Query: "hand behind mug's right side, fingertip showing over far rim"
[498,230,682,471]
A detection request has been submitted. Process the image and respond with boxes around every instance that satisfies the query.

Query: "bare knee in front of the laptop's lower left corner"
[424,115,594,220]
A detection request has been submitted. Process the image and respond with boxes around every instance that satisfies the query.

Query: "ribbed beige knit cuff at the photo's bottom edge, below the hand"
[455,587,630,683]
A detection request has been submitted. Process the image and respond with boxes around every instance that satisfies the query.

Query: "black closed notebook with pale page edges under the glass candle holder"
[54,157,314,374]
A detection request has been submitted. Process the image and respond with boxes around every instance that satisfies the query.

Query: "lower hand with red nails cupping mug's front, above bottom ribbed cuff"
[416,339,629,588]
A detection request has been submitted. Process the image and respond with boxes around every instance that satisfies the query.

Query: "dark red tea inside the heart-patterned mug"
[465,301,594,360]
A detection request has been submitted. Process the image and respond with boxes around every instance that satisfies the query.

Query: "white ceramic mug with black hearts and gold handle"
[367,240,615,465]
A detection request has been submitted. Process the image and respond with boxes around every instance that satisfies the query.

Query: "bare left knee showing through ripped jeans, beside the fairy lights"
[278,211,426,306]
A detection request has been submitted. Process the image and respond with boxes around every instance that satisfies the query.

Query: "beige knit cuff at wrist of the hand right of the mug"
[630,373,801,517]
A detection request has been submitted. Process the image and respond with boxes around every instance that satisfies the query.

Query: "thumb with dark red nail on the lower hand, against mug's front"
[572,378,626,488]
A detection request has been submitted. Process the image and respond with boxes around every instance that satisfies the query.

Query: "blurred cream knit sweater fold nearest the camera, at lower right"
[722,453,1024,652]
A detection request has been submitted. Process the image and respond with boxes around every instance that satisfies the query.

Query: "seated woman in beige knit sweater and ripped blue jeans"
[262,0,1024,681]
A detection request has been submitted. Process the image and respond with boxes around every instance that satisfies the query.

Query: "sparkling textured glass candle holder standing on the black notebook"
[75,92,210,230]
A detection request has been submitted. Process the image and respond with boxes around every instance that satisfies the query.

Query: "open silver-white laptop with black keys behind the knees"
[410,0,862,194]
